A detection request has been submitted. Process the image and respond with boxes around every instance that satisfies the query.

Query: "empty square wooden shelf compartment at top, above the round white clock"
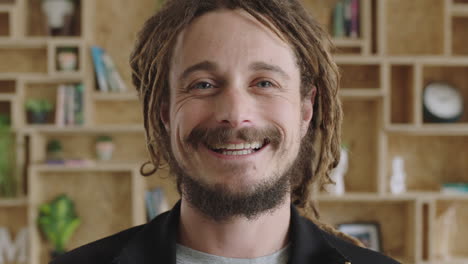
[383,0,445,55]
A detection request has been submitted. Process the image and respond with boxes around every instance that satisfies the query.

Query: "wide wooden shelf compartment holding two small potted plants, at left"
[32,131,148,165]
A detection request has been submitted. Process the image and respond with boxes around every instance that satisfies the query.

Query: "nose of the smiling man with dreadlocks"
[215,87,255,128]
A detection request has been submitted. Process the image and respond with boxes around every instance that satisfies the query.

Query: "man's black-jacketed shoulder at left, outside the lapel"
[49,225,145,264]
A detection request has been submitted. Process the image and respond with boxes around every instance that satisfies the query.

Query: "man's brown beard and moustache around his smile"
[165,127,306,222]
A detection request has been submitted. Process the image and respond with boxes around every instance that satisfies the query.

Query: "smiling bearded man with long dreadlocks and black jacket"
[53,0,396,264]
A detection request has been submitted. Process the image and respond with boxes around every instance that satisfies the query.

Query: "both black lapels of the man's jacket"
[113,201,349,264]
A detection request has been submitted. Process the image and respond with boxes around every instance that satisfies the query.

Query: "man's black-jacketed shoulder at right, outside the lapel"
[322,230,400,264]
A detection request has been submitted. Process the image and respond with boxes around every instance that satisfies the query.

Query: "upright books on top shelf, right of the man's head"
[333,0,359,38]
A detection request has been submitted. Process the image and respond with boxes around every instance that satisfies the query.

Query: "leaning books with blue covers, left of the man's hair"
[91,45,127,92]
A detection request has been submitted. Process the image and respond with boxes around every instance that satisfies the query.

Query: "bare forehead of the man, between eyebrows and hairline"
[172,9,296,76]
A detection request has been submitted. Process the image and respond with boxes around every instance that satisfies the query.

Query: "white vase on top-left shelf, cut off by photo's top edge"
[42,0,74,29]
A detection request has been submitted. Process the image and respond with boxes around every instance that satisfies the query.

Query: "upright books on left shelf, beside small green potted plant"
[55,83,84,126]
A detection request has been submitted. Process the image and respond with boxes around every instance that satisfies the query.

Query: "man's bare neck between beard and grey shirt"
[179,197,291,258]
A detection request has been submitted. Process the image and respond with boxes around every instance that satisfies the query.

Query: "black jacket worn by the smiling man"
[50,202,398,264]
